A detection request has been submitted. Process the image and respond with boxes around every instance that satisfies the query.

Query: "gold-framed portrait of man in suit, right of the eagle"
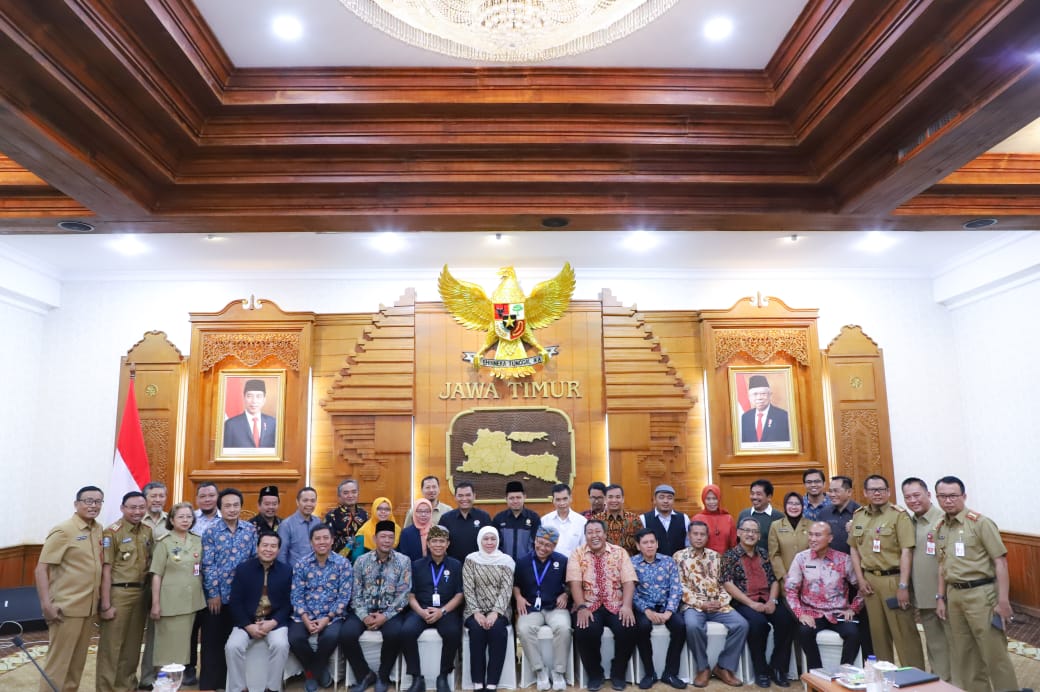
[729,365,799,454]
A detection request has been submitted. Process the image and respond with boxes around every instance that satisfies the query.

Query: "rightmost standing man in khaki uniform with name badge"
[935,476,1018,692]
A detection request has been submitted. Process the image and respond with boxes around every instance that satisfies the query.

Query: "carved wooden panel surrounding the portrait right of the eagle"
[700,297,828,513]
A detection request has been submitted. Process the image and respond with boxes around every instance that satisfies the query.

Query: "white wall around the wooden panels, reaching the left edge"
[0,268,994,545]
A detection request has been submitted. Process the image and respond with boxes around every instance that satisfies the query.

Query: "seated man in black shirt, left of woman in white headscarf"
[401,527,463,692]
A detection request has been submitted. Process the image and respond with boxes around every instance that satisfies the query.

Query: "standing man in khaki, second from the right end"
[902,478,950,683]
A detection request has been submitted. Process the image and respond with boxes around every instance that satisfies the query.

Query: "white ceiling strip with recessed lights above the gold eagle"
[0,231,1019,280]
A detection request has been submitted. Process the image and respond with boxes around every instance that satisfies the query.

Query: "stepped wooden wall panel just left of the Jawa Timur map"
[319,288,420,520]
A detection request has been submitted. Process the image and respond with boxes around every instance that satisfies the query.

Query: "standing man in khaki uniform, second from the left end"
[97,491,152,692]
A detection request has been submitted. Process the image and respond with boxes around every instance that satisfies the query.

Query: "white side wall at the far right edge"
[951,280,1040,534]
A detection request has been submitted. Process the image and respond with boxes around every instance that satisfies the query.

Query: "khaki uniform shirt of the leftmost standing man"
[40,515,102,617]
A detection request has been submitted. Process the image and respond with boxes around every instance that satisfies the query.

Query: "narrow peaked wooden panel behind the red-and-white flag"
[119,331,187,501]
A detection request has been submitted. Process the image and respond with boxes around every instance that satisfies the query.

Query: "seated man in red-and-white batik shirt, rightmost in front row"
[784,521,863,668]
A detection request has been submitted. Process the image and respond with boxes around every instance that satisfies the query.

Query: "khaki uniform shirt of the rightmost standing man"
[936,508,1008,584]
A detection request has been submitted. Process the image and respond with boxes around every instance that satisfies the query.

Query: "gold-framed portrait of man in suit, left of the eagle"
[214,369,285,461]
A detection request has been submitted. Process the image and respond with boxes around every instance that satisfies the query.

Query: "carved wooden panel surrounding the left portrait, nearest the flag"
[184,298,315,499]
